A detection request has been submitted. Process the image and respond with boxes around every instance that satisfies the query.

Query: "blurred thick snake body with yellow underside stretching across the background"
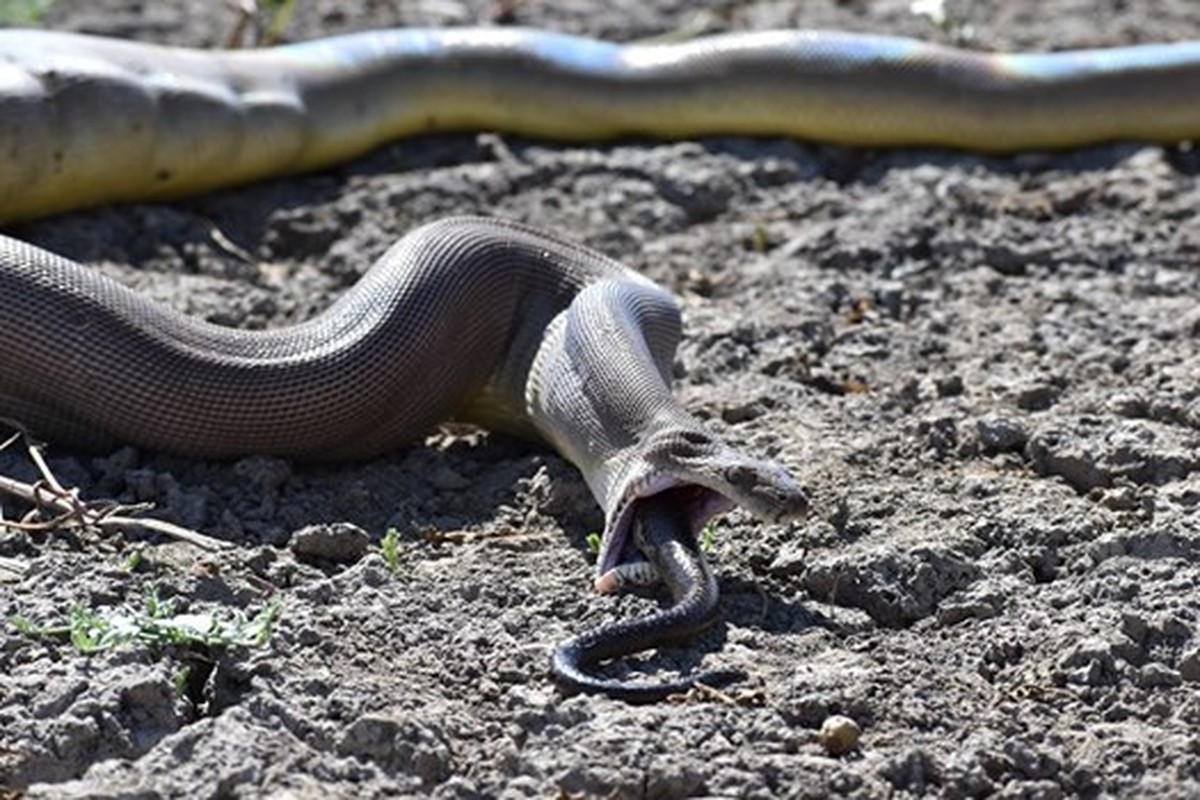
[0,28,1200,221]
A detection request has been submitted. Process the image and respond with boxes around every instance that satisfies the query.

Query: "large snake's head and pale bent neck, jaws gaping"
[526,281,808,591]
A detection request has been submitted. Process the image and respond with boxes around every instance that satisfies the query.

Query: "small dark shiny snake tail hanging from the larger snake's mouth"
[551,489,745,703]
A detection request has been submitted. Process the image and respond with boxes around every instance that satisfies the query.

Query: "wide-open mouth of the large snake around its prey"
[594,473,734,594]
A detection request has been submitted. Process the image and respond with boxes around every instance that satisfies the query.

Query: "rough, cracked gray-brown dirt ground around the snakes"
[0,0,1200,798]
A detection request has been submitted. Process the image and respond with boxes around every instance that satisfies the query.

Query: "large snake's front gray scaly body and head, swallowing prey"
[0,218,806,695]
